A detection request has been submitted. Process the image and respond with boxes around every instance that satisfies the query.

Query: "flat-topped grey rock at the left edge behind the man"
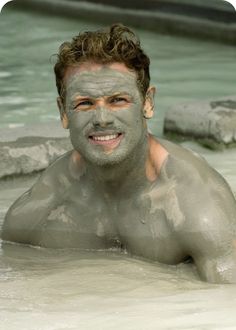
[0,123,72,179]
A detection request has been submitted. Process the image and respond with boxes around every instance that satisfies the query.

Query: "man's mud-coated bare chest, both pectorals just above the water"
[45,183,185,263]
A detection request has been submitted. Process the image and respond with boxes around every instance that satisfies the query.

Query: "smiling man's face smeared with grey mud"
[61,63,146,165]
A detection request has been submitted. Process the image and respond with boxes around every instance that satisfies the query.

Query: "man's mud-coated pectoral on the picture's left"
[42,187,120,249]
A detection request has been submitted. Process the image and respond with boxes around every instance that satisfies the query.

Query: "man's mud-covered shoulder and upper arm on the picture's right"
[161,143,236,283]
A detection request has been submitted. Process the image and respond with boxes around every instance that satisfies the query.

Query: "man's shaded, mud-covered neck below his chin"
[87,134,148,195]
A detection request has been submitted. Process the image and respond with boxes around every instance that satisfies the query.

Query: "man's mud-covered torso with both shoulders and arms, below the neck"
[3,137,236,283]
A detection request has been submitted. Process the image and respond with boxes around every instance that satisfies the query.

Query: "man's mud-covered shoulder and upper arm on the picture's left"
[2,152,82,244]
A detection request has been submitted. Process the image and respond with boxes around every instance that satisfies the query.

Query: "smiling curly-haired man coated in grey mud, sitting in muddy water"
[2,24,236,283]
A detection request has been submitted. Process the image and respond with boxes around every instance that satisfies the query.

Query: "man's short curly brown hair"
[54,24,150,98]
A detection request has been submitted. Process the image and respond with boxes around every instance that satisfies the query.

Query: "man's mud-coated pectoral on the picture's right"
[116,191,184,263]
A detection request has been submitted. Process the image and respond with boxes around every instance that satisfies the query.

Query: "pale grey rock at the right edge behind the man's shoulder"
[164,96,236,149]
